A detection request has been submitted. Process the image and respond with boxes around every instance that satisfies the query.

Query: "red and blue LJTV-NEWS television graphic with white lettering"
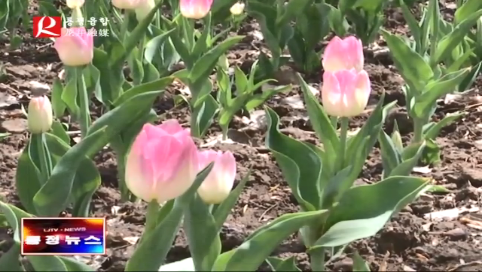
[21,217,106,255]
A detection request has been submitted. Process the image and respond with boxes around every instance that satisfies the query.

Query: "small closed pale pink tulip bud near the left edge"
[27,96,53,134]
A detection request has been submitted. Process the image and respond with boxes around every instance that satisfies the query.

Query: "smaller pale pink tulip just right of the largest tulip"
[197,150,236,204]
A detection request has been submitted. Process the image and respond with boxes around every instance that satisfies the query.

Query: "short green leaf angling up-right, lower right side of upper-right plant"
[412,68,470,119]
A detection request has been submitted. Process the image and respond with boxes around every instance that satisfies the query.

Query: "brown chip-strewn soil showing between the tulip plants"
[0,1,482,271]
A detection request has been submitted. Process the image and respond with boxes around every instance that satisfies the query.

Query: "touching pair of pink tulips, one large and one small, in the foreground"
[125,120,236,204]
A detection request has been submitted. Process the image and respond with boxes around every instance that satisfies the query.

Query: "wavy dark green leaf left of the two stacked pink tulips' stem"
[265,108,322,211]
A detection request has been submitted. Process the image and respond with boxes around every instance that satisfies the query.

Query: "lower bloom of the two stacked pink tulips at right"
[321,69,371,117]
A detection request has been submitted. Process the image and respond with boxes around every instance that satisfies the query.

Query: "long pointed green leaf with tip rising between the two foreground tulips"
[125,163,213,271]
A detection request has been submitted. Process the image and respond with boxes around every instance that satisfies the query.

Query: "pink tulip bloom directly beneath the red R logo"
[54,27,94,66]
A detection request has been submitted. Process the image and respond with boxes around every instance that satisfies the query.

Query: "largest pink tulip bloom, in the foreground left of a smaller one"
[125,119,198,203]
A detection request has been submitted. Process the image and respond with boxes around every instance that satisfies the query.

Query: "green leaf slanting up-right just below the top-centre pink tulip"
[189,36,244,87]
